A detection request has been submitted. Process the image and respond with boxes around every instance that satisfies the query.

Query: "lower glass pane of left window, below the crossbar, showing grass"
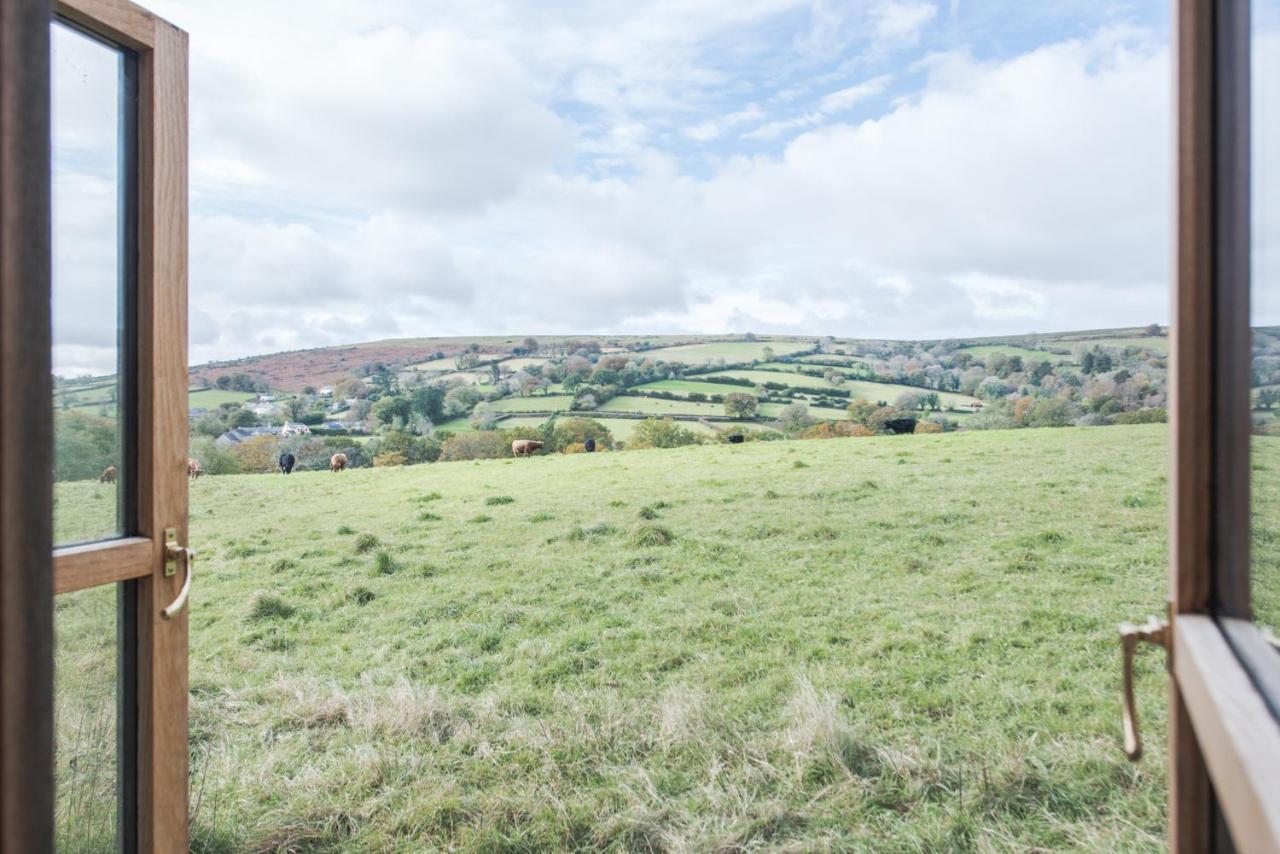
[54,584,116,854]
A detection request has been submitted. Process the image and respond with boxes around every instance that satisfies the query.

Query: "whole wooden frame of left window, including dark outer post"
[0,0,188,853]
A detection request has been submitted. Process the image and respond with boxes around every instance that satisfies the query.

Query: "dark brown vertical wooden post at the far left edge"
[0,0,54,851]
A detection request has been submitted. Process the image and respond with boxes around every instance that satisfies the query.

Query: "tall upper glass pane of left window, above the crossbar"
[52,24,124,545]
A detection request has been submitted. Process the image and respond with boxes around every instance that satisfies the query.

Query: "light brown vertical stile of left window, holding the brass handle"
[137,19,188,853]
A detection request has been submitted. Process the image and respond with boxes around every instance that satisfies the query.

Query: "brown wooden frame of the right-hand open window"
[1169,0,1280,851]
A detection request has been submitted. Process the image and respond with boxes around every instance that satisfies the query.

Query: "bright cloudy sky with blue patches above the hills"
[42,0,1280,374]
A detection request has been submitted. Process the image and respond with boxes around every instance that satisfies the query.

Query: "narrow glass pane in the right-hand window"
[1251,0,1280,629]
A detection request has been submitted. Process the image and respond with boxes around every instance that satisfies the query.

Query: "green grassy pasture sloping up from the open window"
[49,425,1239,851]
